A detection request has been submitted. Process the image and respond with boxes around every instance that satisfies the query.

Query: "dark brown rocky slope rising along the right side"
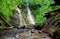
[42,10,60,37]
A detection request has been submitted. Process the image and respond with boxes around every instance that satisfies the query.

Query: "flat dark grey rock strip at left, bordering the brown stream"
[0,28,24,35]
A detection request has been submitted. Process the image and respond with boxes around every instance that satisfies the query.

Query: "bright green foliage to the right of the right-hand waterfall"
[29,0,60,23]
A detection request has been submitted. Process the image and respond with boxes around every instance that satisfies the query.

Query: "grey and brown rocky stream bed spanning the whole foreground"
[0,28,52,39]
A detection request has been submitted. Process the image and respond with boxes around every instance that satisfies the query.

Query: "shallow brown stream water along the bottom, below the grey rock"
[0,29,51,39]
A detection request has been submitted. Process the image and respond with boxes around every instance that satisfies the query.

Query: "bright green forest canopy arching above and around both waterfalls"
[0,0,60,23]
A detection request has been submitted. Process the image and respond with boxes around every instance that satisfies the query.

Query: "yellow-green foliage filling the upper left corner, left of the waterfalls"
[0,0,18,21]
